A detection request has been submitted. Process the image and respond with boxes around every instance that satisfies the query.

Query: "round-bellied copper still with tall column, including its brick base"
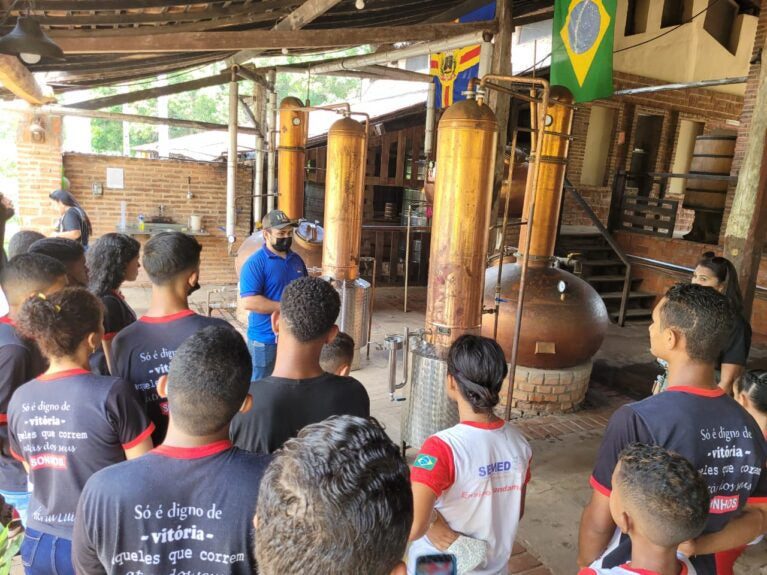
[482,82,608,418]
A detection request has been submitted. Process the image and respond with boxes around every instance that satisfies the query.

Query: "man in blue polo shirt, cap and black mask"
[240,210,307,381]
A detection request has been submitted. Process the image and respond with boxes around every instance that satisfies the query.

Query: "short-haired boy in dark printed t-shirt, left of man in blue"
[111,232,229,445]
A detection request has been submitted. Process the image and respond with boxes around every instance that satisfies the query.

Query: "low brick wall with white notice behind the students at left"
[63,154,252,285]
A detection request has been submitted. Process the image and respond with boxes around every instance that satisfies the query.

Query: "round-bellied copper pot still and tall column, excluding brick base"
[482,87,608,369]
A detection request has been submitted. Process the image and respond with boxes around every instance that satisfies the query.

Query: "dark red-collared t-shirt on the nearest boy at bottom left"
[72,441,269,575]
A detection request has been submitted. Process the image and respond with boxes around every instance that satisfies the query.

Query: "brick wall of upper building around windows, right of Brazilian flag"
[562,72,743,229]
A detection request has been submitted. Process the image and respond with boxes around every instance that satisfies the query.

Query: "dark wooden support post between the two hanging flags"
[488,0,514,215]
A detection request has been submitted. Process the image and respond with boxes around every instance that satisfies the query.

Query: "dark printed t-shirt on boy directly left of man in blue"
[112,310,229,445]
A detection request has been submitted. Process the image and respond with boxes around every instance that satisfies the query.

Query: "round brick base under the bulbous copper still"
[496,361,592,415]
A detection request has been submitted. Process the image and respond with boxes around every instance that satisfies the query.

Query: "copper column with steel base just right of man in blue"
[322,116,371,369]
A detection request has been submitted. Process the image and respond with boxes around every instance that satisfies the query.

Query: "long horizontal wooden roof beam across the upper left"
[56,21,497,54]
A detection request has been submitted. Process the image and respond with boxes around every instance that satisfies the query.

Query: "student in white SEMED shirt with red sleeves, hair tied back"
[408,335,532,575]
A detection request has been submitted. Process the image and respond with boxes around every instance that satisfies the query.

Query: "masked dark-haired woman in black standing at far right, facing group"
[692,252,751,394]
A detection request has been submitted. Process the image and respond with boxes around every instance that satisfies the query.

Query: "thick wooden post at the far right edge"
[724,45,767,317]
